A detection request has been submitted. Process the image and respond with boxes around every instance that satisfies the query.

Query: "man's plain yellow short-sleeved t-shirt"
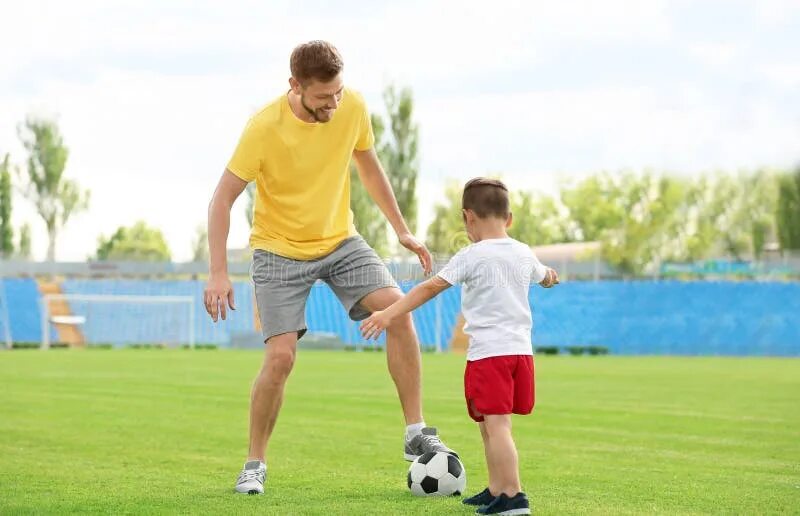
[227,89,375,260]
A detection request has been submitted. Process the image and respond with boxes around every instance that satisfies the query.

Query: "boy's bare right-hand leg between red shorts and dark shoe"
[481,414,522,497]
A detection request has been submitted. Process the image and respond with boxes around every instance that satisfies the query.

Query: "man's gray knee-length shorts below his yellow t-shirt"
[250,236,397,341]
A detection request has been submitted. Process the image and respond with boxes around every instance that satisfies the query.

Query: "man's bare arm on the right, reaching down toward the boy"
[353,147,433,274]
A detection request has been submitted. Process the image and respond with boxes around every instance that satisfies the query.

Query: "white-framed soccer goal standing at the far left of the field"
[41,294,195,349]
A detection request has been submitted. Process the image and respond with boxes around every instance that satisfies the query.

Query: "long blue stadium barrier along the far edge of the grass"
[0,278,800,356]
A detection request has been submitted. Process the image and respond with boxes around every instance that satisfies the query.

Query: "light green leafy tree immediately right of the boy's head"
[508,191,574,245]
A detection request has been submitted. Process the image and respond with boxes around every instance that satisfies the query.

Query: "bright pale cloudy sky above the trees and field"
[0,0,800,261]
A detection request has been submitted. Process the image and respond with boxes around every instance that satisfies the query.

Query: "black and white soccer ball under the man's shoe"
[408,452,467,496]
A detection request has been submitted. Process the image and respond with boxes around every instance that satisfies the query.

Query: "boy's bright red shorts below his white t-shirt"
[464,355,536,422]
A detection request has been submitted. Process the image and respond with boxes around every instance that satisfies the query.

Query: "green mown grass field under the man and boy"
[0,350,800,514]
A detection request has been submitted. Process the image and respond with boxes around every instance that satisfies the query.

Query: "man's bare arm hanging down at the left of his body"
[203,170,247,322]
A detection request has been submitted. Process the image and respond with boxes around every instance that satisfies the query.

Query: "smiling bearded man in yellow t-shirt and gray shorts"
[204,41,452,494]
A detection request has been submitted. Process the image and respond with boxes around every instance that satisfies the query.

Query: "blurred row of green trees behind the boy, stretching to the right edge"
[428,170,780,276]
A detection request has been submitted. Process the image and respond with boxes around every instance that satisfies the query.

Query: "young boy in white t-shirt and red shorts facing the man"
[361,178,558,514]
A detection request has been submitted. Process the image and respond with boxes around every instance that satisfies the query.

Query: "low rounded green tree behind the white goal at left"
[97,221,170,262]
